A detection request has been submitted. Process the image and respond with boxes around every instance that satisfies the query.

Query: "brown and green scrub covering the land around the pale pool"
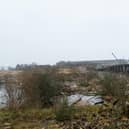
[0,68,129,129]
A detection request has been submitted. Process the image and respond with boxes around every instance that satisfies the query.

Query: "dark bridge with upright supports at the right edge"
[99,64,129,73]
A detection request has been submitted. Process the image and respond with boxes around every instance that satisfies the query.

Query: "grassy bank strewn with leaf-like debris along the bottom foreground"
[0,105,129,129]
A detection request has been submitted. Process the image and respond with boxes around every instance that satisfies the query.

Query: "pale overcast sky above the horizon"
[0,0,129,66]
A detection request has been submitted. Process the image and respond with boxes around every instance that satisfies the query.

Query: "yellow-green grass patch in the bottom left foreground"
[0,108,54,129]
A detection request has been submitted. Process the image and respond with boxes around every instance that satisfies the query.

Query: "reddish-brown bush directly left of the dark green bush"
[19,71,40,107]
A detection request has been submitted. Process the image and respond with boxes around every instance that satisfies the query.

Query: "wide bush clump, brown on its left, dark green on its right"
[20,71,62,107]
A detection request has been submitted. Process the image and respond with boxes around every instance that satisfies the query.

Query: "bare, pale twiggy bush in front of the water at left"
[4,75,24,109]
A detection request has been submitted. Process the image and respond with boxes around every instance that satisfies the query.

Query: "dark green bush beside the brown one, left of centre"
[37,74,62,106]
